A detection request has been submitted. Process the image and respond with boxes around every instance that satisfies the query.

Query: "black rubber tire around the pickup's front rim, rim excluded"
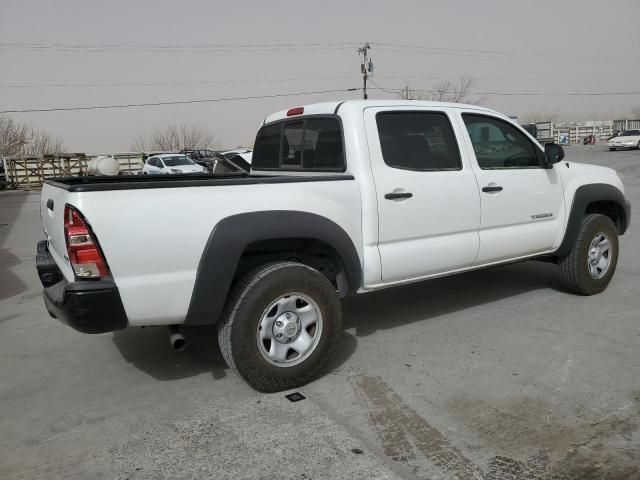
[558,214,618,295]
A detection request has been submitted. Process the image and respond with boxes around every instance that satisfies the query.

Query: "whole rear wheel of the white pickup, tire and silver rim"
[218,262,342,392]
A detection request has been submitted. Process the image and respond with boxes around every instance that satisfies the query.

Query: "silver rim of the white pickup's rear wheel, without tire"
[256,292,323,367]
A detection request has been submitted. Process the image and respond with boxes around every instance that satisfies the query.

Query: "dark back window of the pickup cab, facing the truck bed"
[251,117,344,172]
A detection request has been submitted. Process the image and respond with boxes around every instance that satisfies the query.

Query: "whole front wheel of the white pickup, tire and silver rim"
[559,214,618,295]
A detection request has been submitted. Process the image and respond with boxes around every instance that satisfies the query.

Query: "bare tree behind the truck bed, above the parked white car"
[132,124,216,152]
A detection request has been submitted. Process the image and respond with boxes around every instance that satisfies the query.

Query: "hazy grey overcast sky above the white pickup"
[0,0,640,153]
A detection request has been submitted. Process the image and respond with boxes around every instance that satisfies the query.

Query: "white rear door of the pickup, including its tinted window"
[364,107,480,283]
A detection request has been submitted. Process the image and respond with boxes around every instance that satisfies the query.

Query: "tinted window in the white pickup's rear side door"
[376,112,462,171]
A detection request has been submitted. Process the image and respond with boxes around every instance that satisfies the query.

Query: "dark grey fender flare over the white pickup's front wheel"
[555,183,631,255]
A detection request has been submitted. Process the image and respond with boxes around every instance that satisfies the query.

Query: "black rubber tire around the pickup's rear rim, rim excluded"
[218,262,342,392]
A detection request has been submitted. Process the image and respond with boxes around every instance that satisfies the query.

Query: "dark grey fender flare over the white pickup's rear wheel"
[184,210,362,326]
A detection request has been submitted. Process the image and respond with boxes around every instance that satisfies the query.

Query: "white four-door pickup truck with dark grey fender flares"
[37,100,630,391]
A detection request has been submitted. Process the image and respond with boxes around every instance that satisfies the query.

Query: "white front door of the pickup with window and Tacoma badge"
[461,111,565,265]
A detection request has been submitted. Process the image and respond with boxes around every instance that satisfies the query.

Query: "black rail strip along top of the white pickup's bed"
[45,172,353,192]
